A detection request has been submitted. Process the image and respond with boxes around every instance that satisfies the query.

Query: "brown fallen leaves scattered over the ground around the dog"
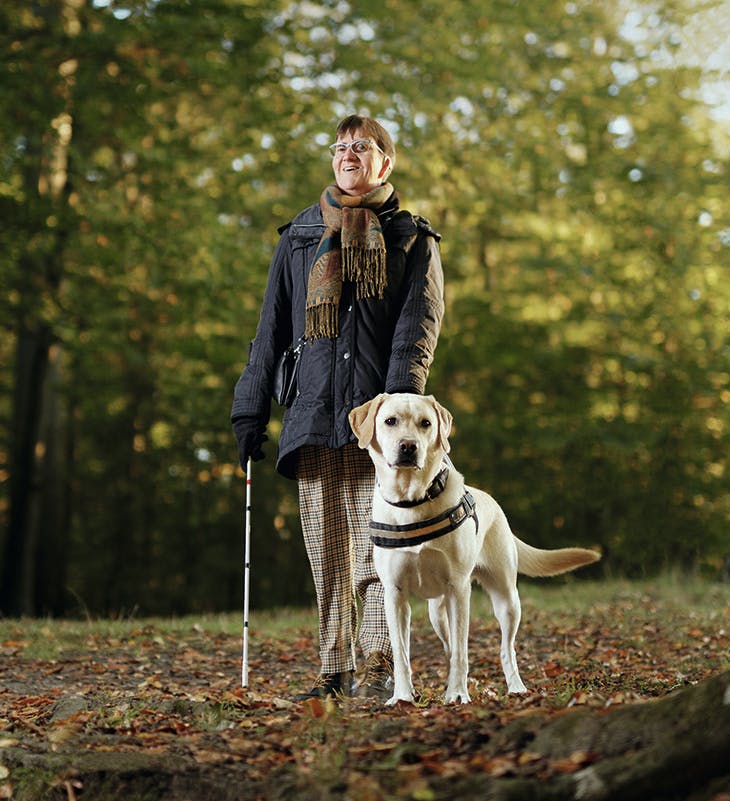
[0,584,730,801]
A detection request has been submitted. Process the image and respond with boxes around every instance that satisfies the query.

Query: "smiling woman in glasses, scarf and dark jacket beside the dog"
[231,115,443,700]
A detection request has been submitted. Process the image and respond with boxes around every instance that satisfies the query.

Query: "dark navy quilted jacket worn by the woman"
[231,199,443,478]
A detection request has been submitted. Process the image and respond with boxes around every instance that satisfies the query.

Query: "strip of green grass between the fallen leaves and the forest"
[0,573,730,660]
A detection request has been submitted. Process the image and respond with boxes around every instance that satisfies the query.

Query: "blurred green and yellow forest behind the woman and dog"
[0,0,730,616]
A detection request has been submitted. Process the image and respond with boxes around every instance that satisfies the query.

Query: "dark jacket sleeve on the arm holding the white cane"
[231,229,292,427]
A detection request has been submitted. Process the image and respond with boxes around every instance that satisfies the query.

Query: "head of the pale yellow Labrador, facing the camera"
[349,393,453,472]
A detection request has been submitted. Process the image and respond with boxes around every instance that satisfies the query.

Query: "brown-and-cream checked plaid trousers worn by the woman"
[297,443,391,674]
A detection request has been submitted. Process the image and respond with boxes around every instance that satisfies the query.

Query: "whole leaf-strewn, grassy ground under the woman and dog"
[0,579,730,801]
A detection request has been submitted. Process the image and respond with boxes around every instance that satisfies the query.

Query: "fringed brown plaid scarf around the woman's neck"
[304,183,393,339]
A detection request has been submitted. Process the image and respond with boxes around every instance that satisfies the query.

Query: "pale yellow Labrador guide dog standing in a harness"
[349,393,600,705]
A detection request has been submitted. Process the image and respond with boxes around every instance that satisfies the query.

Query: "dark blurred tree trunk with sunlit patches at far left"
[0,2,78,616]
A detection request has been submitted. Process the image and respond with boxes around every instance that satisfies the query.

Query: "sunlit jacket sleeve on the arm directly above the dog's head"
[385,225,444,394]
